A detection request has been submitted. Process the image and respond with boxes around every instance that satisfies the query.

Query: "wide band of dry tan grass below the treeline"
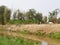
[0,24,60,33]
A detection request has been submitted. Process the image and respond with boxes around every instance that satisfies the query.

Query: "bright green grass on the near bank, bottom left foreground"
[0,35,41,45]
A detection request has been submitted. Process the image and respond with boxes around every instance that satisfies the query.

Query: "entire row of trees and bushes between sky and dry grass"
[0,6,60,25]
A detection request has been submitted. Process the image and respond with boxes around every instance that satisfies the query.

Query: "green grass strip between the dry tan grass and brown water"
[0,27,60,39]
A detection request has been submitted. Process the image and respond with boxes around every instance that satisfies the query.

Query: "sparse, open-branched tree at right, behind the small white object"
[49,9,60,23]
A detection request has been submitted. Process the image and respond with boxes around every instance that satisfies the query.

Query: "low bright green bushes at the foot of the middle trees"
[9,19,37,24]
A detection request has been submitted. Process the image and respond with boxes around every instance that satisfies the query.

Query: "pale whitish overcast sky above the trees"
[0,0,60,17]
